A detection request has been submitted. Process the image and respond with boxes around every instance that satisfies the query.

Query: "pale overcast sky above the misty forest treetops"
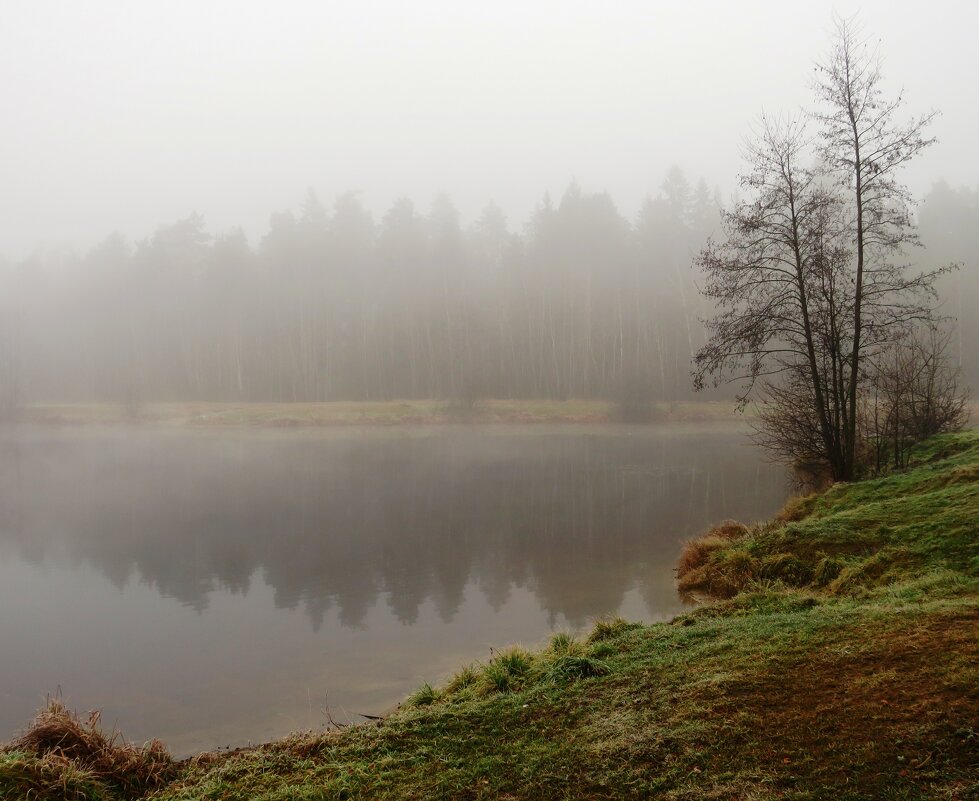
[0,0,979,258]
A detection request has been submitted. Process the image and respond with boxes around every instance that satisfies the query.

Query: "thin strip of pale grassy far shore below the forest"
[9,400,743,428]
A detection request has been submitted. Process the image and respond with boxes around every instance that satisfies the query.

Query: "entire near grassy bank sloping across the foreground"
[0,432,979,801]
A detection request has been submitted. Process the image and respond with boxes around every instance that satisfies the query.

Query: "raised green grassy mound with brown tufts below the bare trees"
[680,431,979,596]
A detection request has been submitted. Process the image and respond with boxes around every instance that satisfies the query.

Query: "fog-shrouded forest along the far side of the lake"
[0,167,979,411]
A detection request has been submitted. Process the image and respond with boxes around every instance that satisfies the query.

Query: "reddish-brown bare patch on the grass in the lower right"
[711,610,979,798]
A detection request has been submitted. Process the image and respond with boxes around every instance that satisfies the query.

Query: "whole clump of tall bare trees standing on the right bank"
[695,21,944,480]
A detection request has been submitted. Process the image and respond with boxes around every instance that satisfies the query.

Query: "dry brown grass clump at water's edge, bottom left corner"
[3,699,174,798]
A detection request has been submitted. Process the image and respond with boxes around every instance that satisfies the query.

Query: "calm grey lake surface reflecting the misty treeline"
[0,426,787,754]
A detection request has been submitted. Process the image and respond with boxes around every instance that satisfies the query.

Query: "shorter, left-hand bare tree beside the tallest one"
[695,118,850,478]
